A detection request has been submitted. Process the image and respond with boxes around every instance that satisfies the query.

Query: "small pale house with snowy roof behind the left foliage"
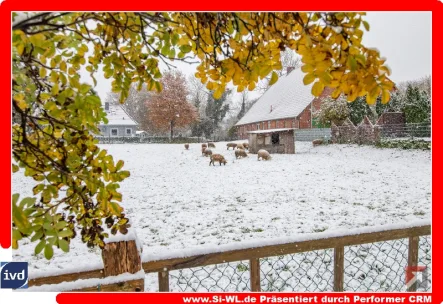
[99,102,138,137]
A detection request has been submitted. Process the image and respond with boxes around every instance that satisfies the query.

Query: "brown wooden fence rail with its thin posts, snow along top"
[29,225,431,292]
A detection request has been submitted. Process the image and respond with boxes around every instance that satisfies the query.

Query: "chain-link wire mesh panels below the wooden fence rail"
[163,236,432,292]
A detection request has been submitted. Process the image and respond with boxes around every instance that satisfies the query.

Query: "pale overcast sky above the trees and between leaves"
[84,12,431,101]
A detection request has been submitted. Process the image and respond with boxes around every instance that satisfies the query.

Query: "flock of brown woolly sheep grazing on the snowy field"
[185,142,271,166]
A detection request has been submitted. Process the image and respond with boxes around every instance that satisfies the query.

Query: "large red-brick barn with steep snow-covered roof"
[235,68,332,139]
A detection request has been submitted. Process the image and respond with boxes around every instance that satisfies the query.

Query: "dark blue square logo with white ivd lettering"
[0,262,28,289]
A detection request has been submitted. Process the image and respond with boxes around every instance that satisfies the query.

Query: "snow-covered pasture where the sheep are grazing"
[13,142,431,290]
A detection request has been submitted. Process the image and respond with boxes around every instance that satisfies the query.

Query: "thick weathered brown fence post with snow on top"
[102,240,145,291]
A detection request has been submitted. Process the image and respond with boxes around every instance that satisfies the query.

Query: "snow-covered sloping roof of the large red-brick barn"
[236,68,315,126]
